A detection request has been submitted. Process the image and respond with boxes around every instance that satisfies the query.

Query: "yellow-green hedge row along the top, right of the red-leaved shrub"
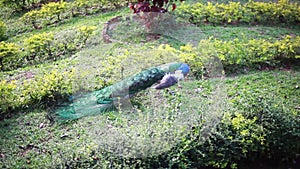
[177,0,300,25]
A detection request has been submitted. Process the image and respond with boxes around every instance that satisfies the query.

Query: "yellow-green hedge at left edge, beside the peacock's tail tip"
[0,70,74,115]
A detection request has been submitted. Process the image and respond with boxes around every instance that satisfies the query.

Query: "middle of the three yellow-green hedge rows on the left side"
[0,26,96,71]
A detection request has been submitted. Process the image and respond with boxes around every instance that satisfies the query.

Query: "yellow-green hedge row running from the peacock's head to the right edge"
[180,35,300,77]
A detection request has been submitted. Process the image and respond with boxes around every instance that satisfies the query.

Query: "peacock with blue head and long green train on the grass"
[50,62,190,121]
